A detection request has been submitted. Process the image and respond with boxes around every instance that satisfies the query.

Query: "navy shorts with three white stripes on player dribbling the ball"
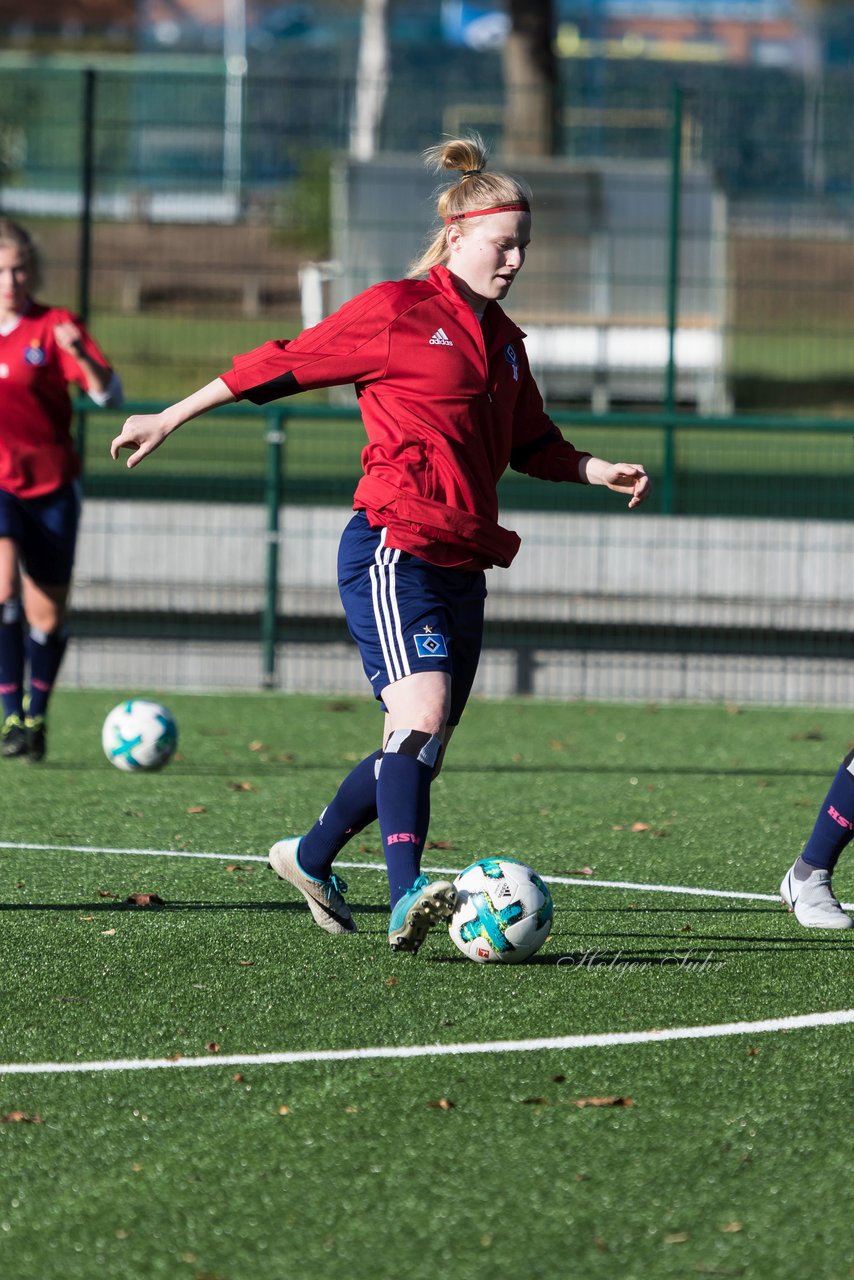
[338,511,487,724]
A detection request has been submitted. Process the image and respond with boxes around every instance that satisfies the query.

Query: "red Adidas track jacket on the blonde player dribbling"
[222,266,586,570]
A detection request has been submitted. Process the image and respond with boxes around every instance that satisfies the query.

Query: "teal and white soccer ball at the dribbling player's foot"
[448,858,553,964]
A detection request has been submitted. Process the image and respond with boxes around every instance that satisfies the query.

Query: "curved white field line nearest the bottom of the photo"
[0,1009,854,1075]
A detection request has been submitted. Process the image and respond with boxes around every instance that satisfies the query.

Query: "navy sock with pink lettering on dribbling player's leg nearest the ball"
[376,728,442,906]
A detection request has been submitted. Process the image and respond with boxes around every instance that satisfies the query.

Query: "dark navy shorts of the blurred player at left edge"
[0,483,81,586]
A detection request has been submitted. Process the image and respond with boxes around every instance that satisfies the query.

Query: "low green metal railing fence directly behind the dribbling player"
[71,401,854,700]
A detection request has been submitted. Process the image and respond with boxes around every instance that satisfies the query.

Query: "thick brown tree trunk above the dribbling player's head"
[503,0,558,160]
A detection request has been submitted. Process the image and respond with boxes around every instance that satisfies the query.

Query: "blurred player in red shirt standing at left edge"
[0,219,122,760]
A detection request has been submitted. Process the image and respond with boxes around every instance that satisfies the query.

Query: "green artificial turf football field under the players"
[0,690,854,1280]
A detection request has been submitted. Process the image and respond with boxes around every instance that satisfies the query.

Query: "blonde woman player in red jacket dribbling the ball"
[111,138,649,952]
